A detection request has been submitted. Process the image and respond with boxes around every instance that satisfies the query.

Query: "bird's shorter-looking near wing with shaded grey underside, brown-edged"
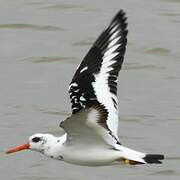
[60,101,120,148]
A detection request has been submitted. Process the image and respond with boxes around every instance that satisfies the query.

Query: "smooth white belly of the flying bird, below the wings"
[62,148,122,166]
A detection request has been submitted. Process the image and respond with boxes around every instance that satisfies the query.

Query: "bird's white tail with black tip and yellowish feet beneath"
[116,145,164,165]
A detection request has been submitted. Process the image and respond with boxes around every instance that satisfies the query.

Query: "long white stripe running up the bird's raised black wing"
[92,38,120,137]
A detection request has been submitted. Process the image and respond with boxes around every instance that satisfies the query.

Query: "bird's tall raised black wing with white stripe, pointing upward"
[69,10,128,137]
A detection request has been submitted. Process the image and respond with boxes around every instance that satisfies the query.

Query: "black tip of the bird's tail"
[143,154,164,164]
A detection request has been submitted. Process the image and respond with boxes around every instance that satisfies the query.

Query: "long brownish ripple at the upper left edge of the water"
[0,23,64,31]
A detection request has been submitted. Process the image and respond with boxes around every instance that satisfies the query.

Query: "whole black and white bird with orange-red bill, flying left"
[6,10,164,166]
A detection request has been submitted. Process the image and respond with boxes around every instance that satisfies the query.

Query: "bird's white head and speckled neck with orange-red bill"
[6,133,67,158]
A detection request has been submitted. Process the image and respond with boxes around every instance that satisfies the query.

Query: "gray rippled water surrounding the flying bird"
[0,0,180,180]
